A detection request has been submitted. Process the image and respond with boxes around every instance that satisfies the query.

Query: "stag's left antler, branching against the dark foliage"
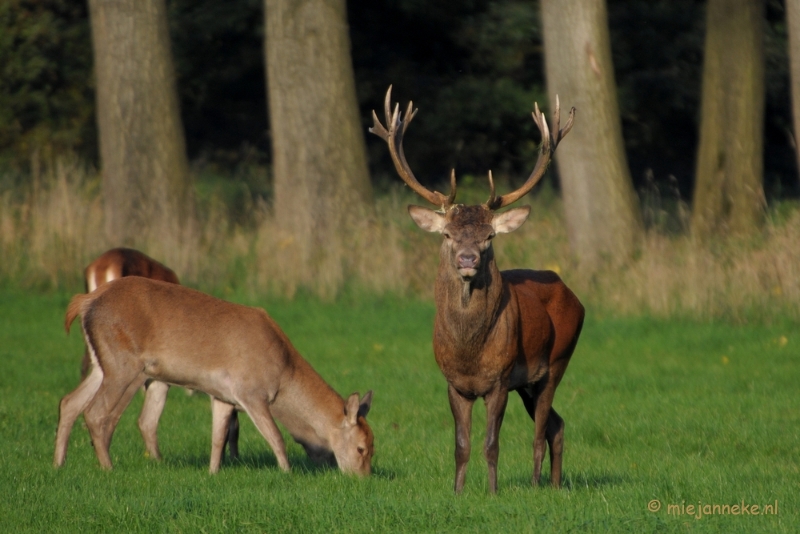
[369,85,456,210]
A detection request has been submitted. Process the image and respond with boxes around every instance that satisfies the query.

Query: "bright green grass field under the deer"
[0,290,800,532]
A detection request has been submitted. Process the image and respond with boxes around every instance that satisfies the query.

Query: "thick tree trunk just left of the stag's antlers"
[265,0,372,296]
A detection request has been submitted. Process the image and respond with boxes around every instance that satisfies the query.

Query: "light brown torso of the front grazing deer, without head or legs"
[67,276,299,404]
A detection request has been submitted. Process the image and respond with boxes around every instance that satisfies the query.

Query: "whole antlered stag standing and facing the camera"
[370,86,584,493]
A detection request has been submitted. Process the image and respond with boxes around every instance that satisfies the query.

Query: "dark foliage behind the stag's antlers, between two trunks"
[348,1,546,183]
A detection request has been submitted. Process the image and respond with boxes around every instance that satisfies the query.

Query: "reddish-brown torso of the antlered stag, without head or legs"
[434,269,583,398]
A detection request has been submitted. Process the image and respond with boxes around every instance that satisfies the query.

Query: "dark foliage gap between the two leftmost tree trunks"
[167,0,269,165]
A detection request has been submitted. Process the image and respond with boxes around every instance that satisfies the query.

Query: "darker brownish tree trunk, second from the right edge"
[692,0,765,240]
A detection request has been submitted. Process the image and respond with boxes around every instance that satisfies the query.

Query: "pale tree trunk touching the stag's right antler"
[542,0,642,265]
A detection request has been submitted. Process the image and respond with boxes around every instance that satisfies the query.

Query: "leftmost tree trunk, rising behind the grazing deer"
[89,0,191,246]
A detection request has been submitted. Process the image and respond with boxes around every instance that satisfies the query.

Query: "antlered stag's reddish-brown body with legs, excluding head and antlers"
[433,209,584,492]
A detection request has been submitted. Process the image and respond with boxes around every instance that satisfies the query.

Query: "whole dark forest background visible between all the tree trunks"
[0,0,800,203]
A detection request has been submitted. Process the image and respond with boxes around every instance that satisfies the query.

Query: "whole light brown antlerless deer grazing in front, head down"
[53,276,373,476]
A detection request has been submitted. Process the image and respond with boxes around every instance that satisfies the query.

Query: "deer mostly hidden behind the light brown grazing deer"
[81,248,239,460]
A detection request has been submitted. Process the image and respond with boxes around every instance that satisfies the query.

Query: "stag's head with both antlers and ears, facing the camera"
[369,86,575,282]
